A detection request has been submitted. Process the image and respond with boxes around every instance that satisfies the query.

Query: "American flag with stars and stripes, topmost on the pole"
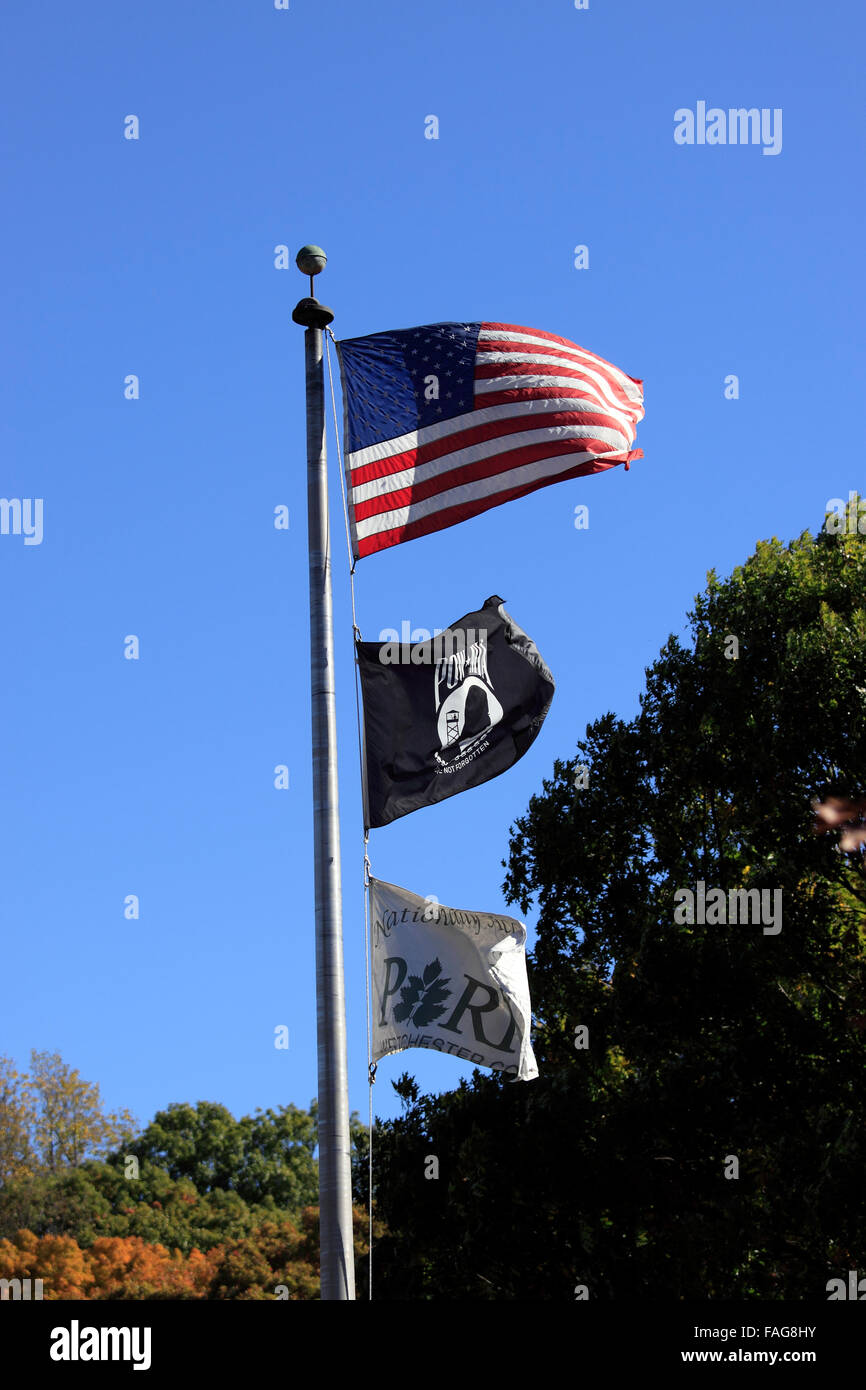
[338,324,644,560]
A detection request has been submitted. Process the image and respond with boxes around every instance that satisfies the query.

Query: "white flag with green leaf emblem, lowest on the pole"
[370,878,538,1081]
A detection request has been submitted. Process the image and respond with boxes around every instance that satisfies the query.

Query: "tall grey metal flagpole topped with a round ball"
[292,246,354,1301]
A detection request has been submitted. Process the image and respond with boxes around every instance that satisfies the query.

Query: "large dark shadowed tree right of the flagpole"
[366,517,866,1301]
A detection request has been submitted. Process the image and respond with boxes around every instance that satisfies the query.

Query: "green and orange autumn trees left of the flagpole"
[0,1052,367,1300]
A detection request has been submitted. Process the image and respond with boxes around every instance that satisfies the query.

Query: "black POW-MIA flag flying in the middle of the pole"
[356,595,553,828]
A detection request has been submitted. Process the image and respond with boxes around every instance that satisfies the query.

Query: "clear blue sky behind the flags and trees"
[0,0,865,1123]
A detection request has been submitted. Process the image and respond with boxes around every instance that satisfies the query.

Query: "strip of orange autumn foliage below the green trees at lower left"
[0,1208,366,1300]
